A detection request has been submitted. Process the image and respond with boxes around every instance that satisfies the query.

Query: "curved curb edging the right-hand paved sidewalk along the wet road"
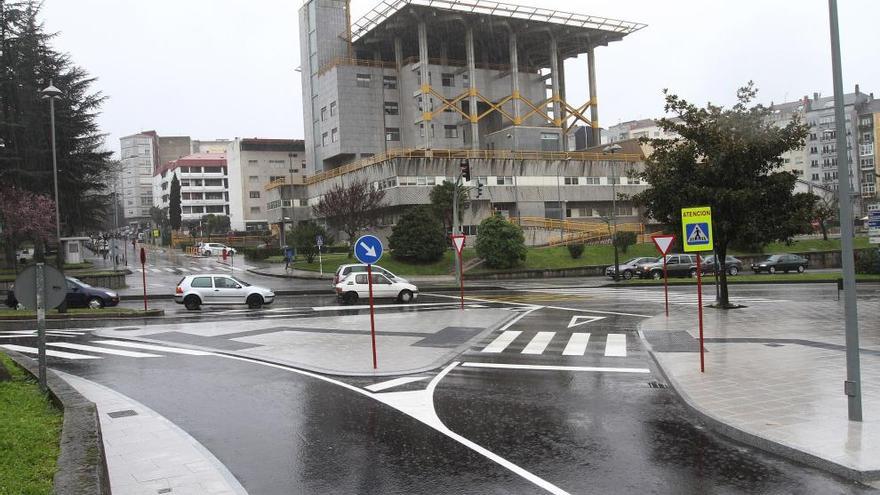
[639,324,880,483]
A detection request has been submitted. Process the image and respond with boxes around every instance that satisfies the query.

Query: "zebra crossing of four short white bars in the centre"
[479,330,627,357]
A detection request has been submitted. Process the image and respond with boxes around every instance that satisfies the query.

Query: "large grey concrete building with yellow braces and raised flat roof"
[268,0,644,247]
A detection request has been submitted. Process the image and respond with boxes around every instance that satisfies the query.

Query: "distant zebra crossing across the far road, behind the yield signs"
[518,287,785,306]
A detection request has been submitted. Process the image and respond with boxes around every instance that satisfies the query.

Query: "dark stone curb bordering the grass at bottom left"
[3,350,111,495]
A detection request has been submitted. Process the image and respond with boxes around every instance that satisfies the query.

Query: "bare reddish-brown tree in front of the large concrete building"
[312,181,385,255]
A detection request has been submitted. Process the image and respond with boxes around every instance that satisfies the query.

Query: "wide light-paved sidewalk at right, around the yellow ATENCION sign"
[640,296,880,481]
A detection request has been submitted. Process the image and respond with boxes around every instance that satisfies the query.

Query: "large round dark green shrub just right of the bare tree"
[388,206,448,263]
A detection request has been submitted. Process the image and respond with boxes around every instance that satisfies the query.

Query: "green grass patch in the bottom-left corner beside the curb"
[0,353,63,495]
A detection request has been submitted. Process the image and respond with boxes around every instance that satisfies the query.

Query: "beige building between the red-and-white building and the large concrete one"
[226,138,306,231]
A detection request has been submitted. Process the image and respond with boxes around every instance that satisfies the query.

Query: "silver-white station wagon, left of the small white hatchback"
[174,274,275,310]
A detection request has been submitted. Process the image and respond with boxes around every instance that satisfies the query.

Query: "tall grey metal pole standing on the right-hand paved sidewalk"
[828,0,862,421]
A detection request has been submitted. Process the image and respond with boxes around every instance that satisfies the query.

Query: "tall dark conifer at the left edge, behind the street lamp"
[0,0,111,235]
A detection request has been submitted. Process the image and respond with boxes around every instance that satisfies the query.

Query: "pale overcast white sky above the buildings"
[43,0,880,153]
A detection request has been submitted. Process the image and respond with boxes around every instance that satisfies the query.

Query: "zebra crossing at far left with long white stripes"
[0,340,214,361]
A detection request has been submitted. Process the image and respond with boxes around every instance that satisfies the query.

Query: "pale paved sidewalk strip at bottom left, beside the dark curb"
[55,371,247,495]
